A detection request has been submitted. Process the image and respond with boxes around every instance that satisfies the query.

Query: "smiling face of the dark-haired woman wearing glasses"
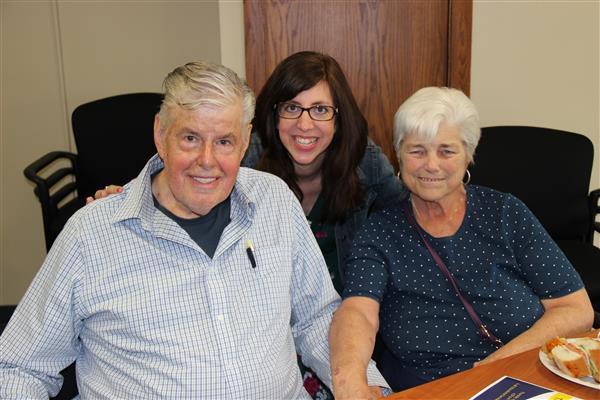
[277,81,335,172]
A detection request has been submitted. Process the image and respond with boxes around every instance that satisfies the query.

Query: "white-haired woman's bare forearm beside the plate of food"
[475,289,594,366]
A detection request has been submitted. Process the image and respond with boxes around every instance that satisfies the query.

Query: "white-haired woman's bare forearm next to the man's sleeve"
[329,296,379,400]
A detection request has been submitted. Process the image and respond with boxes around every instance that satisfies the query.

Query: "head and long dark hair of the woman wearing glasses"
[248,51,366,221]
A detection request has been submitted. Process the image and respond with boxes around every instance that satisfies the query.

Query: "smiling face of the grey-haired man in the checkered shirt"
[152,103,251,218]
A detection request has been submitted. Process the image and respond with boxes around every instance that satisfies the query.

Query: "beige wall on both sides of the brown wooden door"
[0,0,600,304]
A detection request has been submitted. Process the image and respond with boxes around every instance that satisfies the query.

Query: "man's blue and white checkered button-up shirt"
[0,156,387,399]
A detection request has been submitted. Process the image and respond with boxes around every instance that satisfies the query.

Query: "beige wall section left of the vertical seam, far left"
[0,1,69,304]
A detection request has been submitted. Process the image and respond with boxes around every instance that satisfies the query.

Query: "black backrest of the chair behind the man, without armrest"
[72,93,163,198]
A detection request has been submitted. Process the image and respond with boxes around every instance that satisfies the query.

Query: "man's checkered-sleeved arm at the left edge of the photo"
[0,218,83,399]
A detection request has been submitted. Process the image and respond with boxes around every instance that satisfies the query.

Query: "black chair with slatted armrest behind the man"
[23,93,163,250]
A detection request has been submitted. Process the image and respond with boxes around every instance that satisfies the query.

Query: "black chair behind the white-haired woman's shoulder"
[469,126,600,311]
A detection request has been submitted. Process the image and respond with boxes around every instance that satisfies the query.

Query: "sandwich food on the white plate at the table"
[542,337,600,382]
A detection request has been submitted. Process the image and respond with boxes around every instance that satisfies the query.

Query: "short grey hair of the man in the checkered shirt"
[158,61,255,134]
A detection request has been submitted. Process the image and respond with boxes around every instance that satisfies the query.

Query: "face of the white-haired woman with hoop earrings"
[399,124,469,202]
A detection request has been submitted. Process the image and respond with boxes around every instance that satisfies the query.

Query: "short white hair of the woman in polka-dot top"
[394,86,481,162]
